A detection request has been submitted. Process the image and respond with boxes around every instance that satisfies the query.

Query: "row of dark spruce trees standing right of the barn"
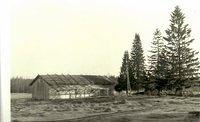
[115,6,200,94]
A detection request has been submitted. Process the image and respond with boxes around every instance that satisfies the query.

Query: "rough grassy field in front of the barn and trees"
[11,94,200,122]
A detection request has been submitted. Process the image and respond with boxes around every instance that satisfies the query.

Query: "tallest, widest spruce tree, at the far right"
[164,6,200,91]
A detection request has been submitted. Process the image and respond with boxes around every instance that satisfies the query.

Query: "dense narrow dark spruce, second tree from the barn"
[130,34,145,90]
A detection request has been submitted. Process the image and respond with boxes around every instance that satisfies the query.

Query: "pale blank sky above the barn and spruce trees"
[11,0,200,78]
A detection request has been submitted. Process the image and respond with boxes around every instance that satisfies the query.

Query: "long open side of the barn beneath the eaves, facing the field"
[49,85,114,99]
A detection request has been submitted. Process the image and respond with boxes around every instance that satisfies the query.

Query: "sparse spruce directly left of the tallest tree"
[148,29,168,94]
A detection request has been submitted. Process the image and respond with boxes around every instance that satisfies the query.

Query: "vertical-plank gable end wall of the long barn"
[32,78,49,100]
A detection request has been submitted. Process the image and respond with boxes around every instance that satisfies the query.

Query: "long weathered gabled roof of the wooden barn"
[29,74,116,86]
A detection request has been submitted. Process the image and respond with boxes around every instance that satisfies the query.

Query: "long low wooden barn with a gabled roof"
[29,74,116,100]
